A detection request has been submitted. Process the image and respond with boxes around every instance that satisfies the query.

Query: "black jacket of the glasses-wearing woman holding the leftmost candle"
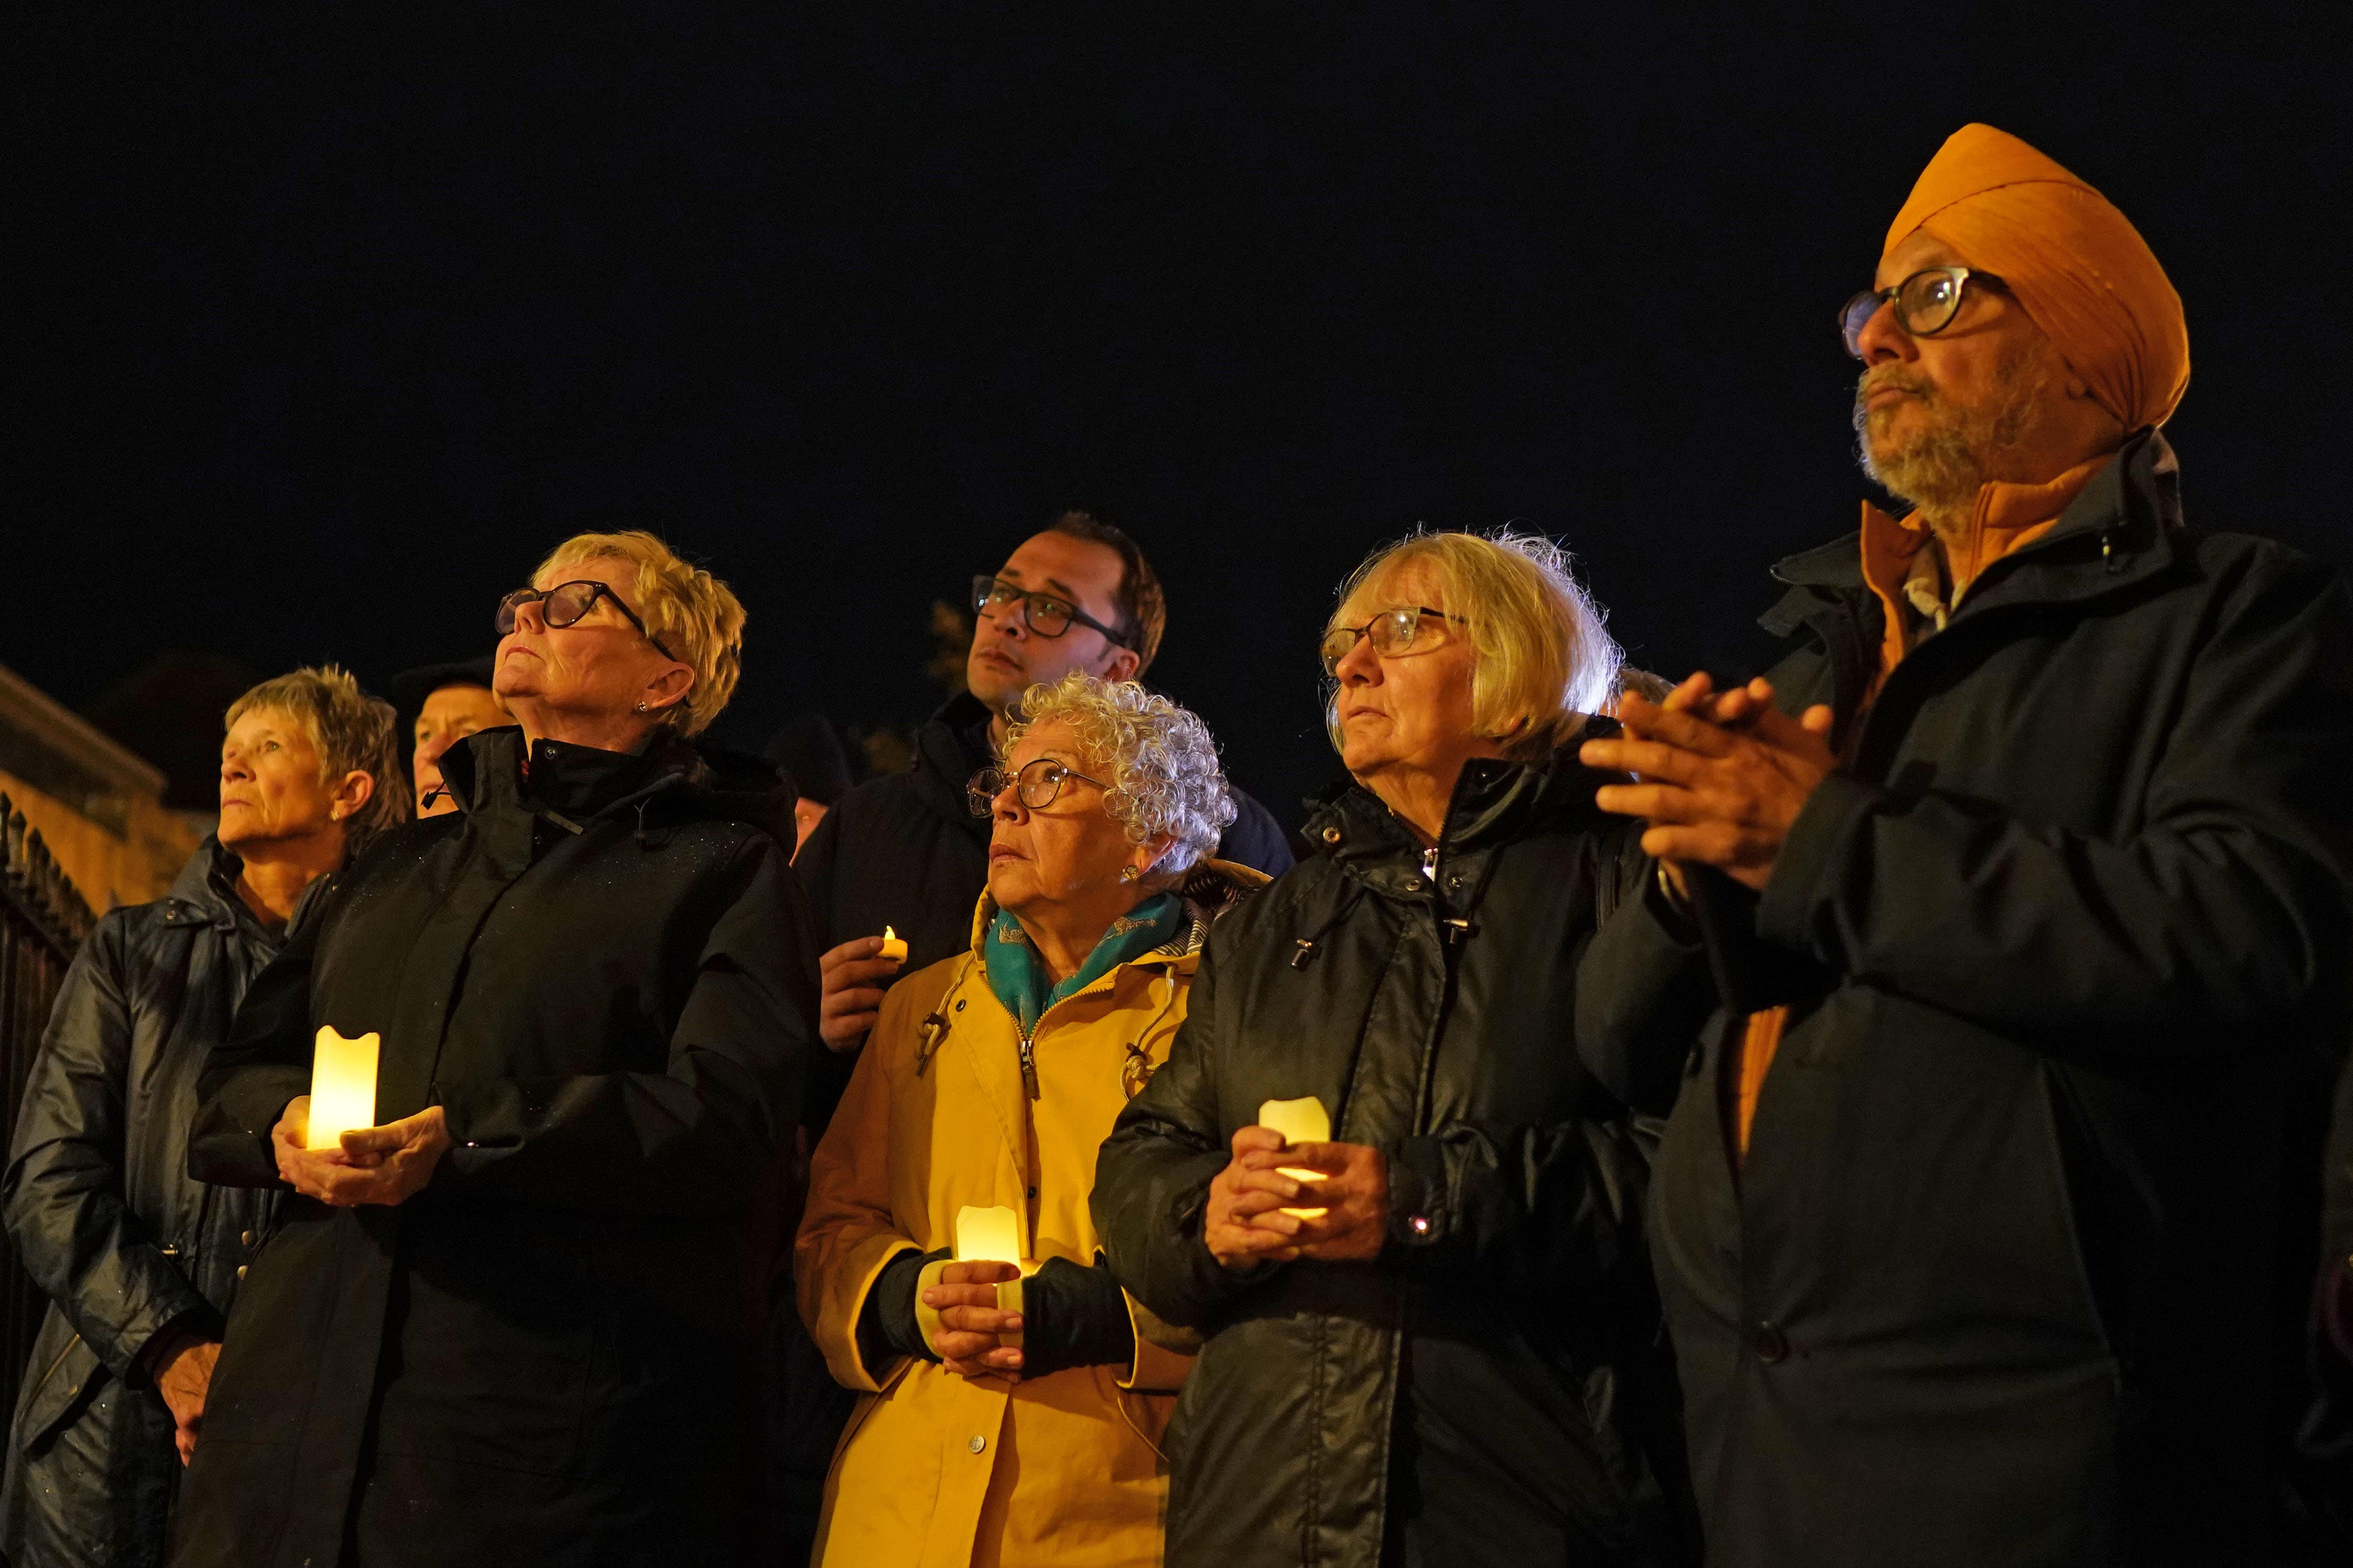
[174,729,816,1568]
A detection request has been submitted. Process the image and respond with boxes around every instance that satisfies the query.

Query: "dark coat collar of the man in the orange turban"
[1758,430,2181,637]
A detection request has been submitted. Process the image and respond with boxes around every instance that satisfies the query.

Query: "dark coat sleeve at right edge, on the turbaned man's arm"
[1758,555,2353,1051]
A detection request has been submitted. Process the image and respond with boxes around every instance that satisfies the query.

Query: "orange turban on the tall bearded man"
[1887,125,2191,430]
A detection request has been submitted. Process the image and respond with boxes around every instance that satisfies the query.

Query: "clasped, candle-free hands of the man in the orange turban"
[1576,675,1837,891]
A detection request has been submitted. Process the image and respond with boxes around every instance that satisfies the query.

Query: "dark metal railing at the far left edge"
[0,795,94,1429]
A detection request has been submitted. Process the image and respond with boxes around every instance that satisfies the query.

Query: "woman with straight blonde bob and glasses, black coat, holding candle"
[1094,534,1697,1568]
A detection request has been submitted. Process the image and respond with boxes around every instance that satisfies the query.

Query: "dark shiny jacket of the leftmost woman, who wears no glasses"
[0,839,327,1568]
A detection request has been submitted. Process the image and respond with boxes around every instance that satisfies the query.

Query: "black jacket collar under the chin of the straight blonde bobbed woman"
[1306,717,1617,877]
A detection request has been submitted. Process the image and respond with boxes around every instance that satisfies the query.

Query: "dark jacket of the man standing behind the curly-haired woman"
[793,696,1292,976]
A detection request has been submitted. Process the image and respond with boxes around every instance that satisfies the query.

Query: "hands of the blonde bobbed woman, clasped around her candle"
[1202,1126,1388,1269]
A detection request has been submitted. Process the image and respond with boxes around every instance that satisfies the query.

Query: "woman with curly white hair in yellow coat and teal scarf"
[798,675,1266,1568]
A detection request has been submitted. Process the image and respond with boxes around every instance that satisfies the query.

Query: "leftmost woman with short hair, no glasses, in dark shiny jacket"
[0,665,407,1568]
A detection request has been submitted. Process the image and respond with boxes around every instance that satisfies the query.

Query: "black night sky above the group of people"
[0,5,2353,814]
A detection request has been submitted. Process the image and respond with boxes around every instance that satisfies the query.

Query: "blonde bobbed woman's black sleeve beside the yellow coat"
[1090,940,1268,1328]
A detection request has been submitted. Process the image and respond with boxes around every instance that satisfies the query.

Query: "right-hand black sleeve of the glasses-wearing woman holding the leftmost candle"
[433,834,819,1215]
